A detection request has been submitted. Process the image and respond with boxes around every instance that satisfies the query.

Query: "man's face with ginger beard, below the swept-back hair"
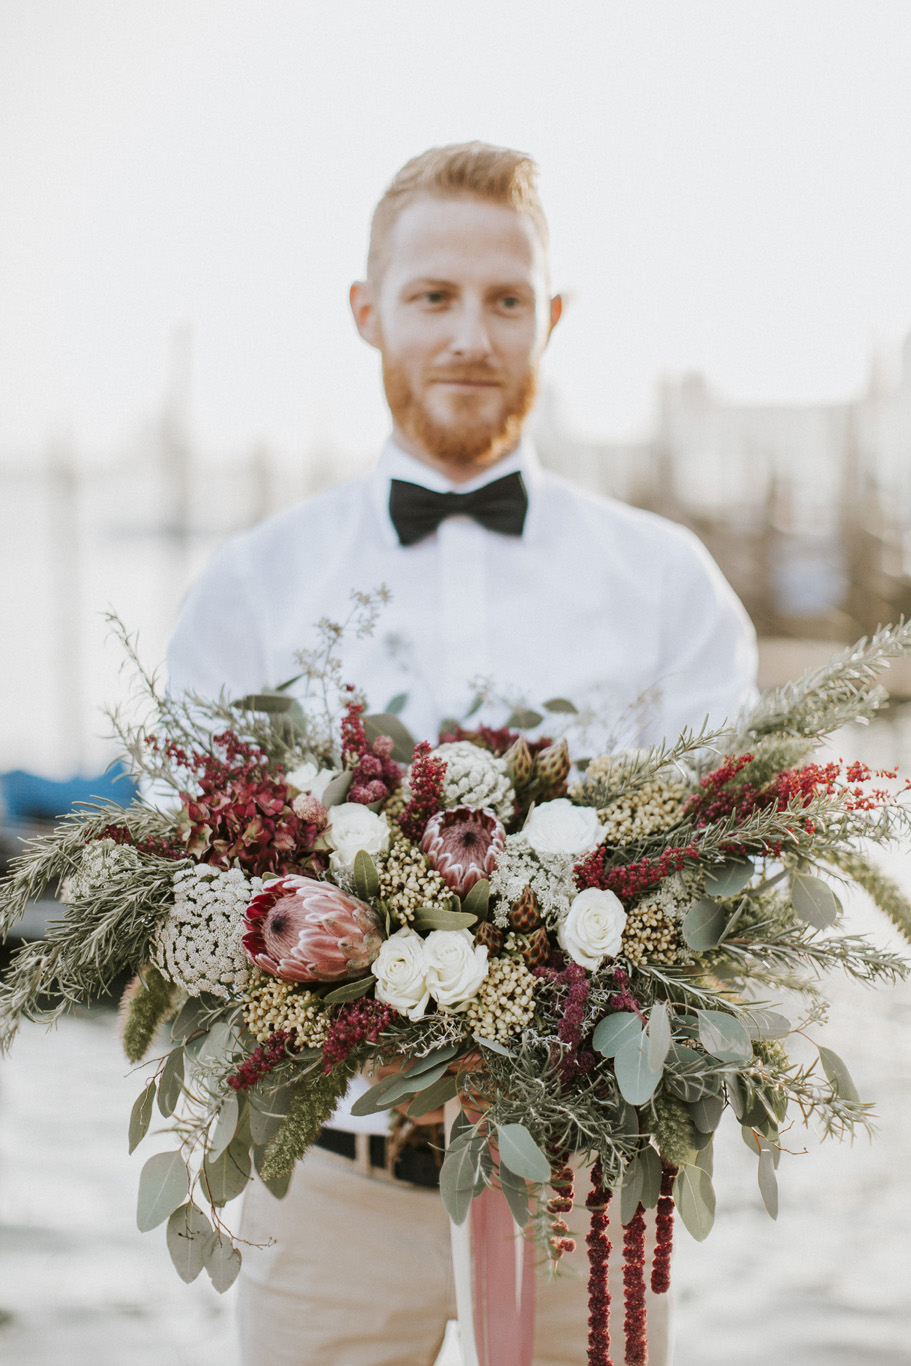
[351,195,560,478]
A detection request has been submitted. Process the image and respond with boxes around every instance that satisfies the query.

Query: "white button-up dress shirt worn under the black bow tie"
[168,441,755,754]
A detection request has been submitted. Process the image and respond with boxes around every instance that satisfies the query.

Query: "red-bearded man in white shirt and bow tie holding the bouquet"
[169,143,755,1366]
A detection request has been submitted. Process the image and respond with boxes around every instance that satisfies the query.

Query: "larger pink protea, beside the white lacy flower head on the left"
[243,874,382,982]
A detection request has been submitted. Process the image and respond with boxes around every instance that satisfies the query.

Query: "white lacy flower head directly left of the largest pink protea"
[150,863,262,999]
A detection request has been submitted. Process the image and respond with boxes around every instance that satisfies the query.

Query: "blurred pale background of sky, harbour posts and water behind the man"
[0,0,911,1366]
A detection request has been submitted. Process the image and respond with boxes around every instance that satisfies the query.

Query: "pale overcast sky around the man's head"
[0,0,911,462]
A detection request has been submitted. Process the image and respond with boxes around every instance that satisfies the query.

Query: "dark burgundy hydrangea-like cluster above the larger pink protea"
[158,731,325,876]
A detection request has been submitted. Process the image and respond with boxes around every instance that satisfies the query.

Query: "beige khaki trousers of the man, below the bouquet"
[239,1147,671,1366]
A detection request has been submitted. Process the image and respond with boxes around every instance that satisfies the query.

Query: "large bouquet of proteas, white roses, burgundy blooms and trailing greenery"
[0,600,911,1363]
